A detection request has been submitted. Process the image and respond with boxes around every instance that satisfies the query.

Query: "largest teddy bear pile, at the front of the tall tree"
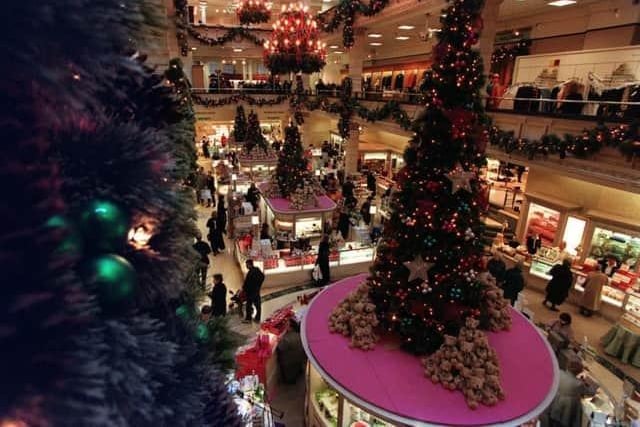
[422,317,505,409]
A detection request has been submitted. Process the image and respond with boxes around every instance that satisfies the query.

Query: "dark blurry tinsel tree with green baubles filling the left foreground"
[0,0,240,427]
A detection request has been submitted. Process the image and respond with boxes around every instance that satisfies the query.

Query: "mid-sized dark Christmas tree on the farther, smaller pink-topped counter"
[275,123,311,197]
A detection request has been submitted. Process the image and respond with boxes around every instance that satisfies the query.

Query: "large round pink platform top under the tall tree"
[302,274,558,426]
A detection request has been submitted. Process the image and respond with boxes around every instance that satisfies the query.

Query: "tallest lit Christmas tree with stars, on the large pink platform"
[369,0,500,354]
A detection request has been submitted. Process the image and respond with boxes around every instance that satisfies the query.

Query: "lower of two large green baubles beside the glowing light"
[86,254,137,305]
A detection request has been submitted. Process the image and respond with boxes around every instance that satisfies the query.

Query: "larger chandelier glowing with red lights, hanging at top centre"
[264,3,327,74]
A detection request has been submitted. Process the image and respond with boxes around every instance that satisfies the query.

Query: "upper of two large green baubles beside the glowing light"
[80,200,129,252]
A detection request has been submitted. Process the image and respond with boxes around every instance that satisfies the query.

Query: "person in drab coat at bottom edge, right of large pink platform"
[540,358,586,427]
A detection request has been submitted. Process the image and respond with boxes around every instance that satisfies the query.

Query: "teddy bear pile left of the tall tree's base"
[329,282,378,350]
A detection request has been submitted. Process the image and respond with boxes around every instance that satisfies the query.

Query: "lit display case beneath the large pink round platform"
[306,364,395,427]
